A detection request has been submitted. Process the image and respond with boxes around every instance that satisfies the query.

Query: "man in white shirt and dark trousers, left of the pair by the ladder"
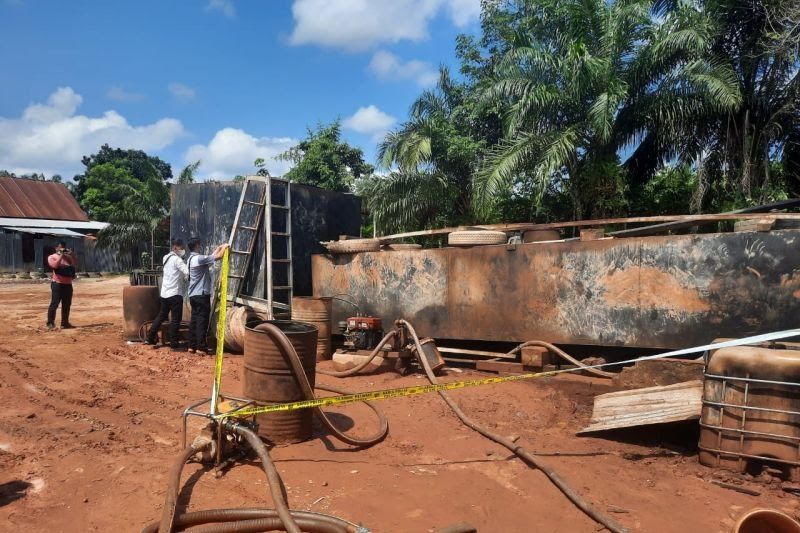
[147,239,189,351]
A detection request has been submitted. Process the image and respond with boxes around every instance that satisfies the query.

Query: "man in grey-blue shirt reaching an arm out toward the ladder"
[187,238,228,353]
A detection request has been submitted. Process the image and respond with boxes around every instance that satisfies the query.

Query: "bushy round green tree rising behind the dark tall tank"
[276,121,374,192]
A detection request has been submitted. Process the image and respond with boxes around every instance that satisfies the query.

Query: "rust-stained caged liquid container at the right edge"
[699,346,800,481]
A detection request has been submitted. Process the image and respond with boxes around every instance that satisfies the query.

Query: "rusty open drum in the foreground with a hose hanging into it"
[244,320,317,444]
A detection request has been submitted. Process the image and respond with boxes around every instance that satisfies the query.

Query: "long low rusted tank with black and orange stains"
[313,230,800,348]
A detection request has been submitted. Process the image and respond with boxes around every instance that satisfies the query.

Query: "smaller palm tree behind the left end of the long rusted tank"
[358,68,494,233]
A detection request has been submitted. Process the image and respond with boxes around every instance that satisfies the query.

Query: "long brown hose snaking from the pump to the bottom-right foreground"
[398,320,628,533]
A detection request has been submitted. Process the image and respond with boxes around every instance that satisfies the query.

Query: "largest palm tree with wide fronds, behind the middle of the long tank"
[473,0,741,218]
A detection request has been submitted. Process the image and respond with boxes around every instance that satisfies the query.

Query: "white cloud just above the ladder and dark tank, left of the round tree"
[185,128,299,180]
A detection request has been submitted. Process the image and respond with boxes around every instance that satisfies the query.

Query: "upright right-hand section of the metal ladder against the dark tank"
[264,178,294,320]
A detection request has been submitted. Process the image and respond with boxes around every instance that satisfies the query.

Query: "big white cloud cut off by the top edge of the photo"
[289,0,480,52]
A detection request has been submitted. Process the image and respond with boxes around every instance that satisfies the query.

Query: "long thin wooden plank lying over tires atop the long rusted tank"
[370,213,800,244]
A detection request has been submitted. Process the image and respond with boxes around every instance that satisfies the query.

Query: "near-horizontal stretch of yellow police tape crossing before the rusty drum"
[214,371,559,419]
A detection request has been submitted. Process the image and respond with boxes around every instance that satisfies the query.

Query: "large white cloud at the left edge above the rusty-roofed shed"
[0,87,184,176]
